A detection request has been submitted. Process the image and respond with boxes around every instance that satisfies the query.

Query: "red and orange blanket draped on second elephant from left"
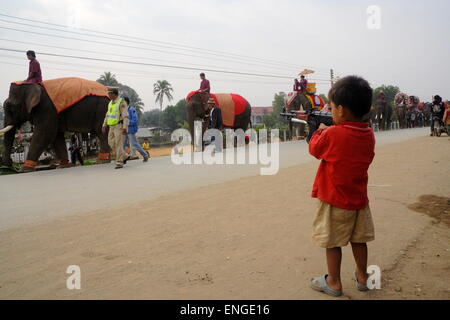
[186,91,248,128]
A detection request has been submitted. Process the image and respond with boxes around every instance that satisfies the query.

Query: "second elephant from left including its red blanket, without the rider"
[186,91,252,144]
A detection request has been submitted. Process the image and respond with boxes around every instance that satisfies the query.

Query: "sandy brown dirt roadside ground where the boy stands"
[0,137,450,300]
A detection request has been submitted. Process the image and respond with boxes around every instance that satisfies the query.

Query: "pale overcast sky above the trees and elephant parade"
[0,0,450,110]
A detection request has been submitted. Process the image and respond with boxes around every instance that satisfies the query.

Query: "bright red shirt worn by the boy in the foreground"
[309,122,375,210]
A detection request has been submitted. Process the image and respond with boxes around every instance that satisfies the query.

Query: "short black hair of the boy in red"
[328,76,373,118]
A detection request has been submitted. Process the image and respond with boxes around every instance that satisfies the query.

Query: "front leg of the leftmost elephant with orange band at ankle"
[22,125,56,172]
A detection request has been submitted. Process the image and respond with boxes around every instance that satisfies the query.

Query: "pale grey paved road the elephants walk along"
[0,129,429,231]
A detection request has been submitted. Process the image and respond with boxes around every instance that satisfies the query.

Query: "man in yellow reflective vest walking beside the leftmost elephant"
[103,88,130,169]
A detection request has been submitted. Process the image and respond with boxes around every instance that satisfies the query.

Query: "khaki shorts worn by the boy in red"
[313,201,375,249]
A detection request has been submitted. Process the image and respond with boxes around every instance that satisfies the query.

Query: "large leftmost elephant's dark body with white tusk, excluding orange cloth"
[0,83,110,172]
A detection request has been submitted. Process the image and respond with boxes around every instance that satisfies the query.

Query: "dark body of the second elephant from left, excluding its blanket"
[186,92,252,145]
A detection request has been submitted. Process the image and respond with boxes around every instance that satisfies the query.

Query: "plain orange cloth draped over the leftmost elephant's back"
[40,78,108,113]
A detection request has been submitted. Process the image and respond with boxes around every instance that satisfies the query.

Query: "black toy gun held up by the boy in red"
[280,109,333,143]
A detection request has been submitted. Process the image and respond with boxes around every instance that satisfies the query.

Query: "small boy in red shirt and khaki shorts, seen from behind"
[309,76,375,297]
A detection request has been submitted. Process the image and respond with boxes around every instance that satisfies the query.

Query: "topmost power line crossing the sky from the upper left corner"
[0,13,328,70]
